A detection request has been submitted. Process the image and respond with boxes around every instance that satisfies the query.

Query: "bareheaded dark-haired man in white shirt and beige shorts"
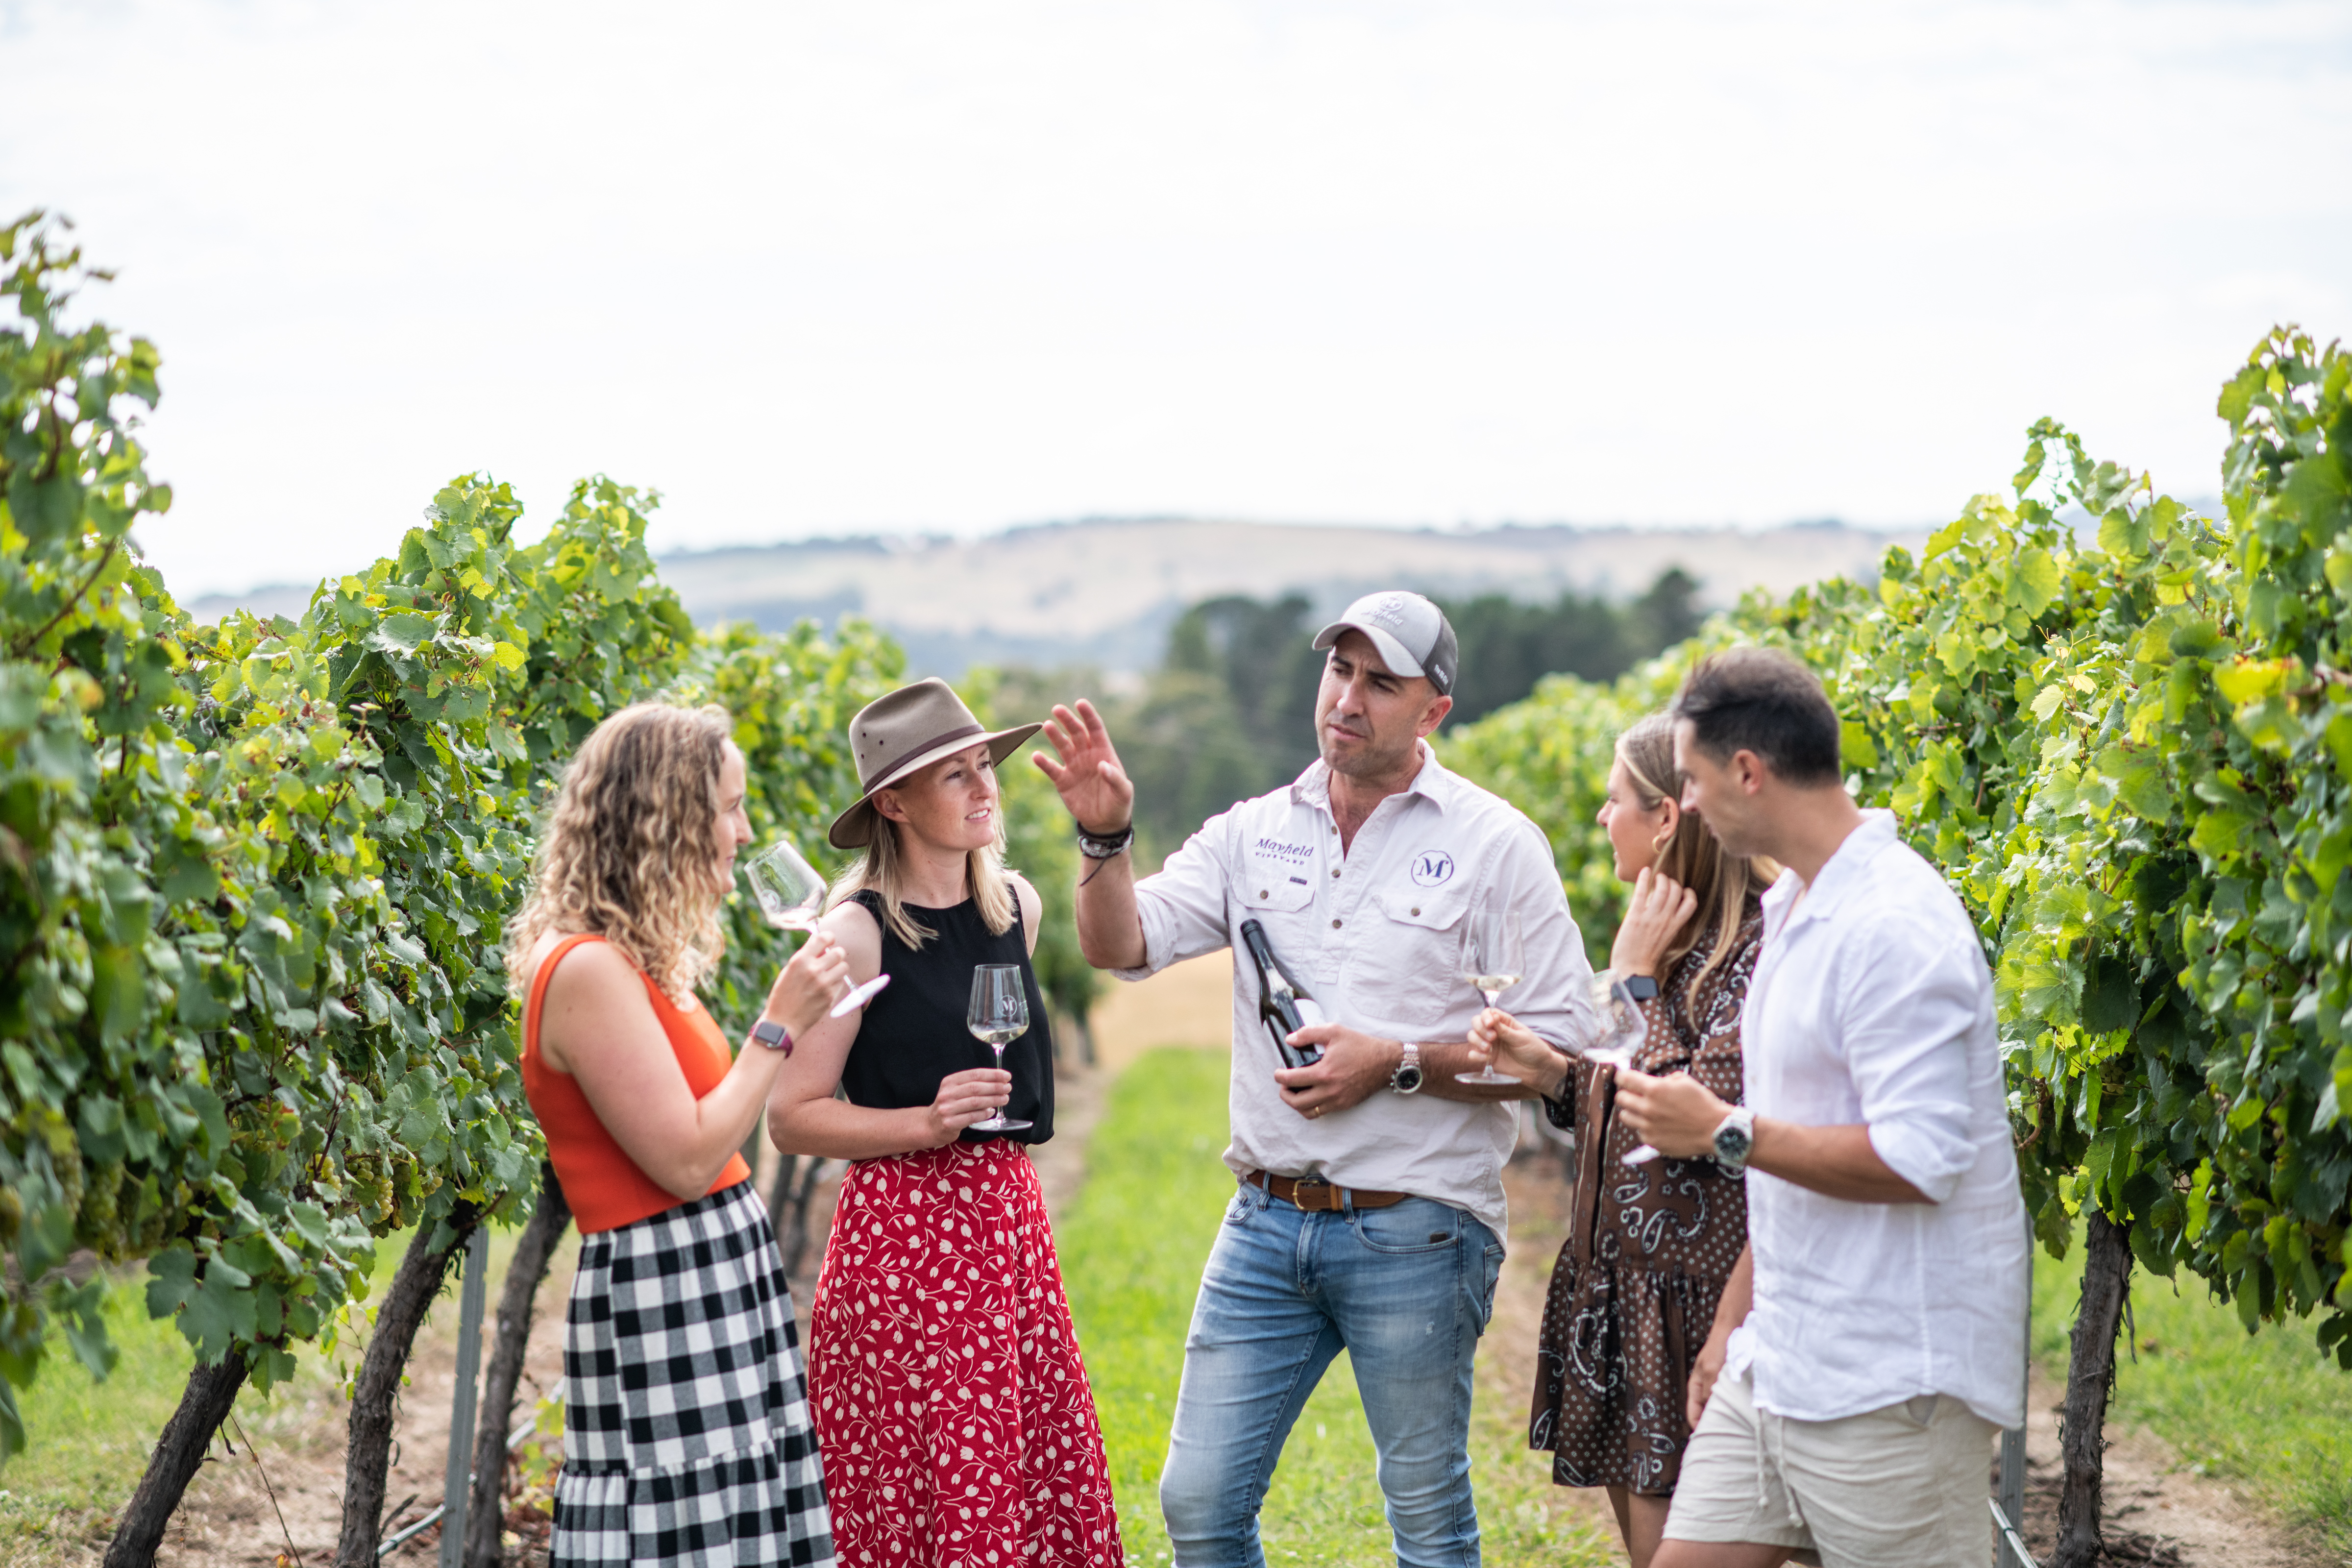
[1618,646,2028,1568]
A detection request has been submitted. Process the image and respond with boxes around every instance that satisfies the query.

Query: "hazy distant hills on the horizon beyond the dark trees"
[188,519,1926,675]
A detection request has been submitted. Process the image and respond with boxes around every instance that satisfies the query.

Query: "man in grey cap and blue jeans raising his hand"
[1037,592,1590,1568]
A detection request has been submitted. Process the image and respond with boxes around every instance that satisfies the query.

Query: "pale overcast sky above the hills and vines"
[0,0,2352,595]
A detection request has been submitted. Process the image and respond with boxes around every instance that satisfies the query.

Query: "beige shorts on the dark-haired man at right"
[1665,1375,1994,1568]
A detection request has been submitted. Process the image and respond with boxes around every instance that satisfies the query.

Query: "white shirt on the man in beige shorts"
[1726,811,2028,1427]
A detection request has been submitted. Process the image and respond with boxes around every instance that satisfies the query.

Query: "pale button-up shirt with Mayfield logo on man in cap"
[1115,745,1592,1239]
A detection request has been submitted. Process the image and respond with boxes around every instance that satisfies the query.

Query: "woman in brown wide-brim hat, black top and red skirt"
[767,680,1124,1568]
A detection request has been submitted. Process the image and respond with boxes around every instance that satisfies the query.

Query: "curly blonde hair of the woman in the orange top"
[506,703,734,1004]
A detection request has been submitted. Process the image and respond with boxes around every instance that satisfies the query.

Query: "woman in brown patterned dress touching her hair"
[1472,714,1778,1568]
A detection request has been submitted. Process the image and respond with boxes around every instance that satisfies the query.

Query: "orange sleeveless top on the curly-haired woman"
[522,935,750,1234]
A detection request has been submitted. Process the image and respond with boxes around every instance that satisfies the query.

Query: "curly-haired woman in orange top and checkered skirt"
[508,703,847,1568]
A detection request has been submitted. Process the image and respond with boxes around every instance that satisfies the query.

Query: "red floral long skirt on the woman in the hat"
[809,1138,1124,1568]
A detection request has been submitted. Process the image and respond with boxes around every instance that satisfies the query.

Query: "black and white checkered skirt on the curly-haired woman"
[553,1182,833,1568]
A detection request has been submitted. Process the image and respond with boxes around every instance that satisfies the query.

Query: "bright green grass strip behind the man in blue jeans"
[1056,1051,1620,1568]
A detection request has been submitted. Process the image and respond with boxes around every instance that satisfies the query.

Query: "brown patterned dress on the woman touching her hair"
[1526,900,1764,1497]
